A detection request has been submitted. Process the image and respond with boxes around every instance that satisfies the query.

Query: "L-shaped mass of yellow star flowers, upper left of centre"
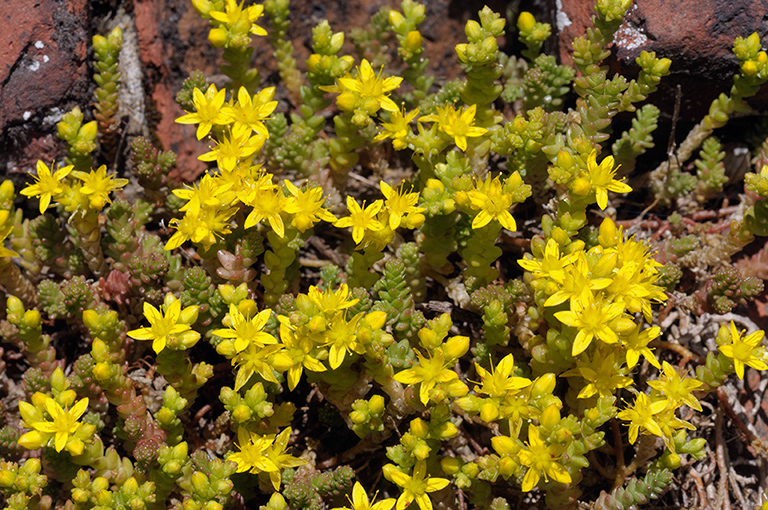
[170,85,346,250]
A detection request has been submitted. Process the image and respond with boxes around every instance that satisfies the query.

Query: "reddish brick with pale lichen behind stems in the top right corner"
[553,0,768,121]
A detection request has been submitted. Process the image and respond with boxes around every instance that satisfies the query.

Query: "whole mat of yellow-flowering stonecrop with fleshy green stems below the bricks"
[0,0,768,510]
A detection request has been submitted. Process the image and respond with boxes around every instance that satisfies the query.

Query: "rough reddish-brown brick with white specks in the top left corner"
[0,0,91,172]
